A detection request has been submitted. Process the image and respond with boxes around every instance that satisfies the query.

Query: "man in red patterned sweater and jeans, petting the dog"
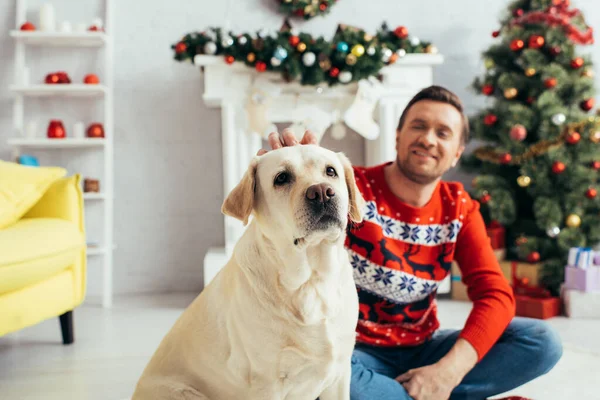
[259,86,562,400]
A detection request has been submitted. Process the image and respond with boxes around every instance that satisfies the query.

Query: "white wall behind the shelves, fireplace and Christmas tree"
[0,0,600,295]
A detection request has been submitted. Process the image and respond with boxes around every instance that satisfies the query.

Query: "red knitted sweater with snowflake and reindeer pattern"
[346,163,515,360]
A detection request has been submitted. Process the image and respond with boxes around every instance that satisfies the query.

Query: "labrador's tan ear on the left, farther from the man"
[221,157,258,226]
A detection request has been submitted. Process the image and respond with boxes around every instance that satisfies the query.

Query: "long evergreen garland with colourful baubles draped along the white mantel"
[171,20,437,86]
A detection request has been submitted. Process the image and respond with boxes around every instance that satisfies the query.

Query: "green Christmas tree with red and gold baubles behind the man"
[462,0,600,295]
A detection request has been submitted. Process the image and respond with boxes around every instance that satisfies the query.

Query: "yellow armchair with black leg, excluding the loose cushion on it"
[0,175,86,344]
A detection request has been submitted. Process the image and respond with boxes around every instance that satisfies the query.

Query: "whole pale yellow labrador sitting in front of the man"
[133,145,364,400]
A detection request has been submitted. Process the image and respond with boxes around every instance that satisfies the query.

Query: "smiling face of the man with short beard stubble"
[396,100,464,184]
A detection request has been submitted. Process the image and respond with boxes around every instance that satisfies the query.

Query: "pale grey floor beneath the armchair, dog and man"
[0,294,600,400]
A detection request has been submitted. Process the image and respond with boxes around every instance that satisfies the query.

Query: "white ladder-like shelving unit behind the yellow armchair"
[8,0,115,307]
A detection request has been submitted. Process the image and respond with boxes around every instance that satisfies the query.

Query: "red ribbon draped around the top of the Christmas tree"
[512,0,594,45]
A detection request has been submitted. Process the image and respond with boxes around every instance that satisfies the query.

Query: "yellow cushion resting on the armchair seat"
[0,160,67,229]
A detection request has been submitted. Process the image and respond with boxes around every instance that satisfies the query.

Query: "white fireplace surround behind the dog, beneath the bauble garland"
[194,54,450,293]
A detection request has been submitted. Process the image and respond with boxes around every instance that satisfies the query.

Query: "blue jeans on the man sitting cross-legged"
[350,317,562,400]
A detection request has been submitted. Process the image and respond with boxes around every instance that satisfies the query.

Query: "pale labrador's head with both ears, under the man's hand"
[222,145,364,244]
